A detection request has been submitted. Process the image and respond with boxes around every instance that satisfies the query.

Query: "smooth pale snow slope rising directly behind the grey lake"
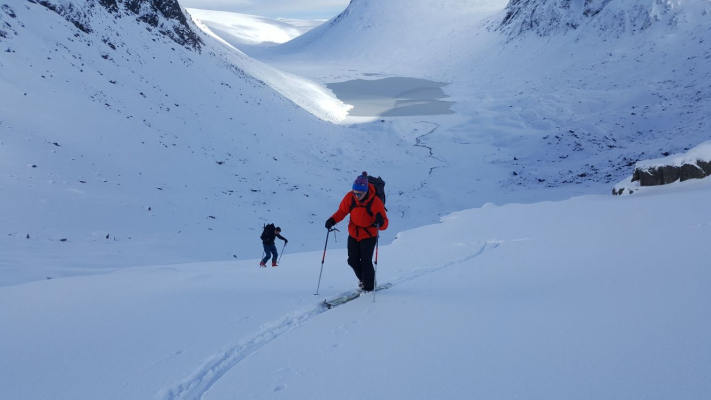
[266,0,506,76]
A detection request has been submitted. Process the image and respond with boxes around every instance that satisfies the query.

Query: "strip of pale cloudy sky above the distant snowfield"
[178,0,350,19]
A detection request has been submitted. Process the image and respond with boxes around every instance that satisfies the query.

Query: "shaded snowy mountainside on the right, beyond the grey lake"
[260,0,711,200]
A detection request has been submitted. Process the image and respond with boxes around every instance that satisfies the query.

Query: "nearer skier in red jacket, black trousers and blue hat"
[326,172,388,292]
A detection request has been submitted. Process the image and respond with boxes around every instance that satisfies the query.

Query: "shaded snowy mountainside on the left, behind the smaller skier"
[0,0,394,284]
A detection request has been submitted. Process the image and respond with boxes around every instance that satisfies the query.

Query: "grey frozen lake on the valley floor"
[326,78,454,117]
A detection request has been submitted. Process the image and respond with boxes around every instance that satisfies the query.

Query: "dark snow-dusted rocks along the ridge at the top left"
[27,0,203,51]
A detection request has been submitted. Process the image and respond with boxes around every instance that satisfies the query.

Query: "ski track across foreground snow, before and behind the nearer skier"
[154,240,504,400]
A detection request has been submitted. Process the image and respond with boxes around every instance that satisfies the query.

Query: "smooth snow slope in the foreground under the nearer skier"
[0,179,711,400]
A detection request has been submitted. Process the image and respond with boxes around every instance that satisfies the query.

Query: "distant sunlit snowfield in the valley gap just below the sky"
[187,8,325,48]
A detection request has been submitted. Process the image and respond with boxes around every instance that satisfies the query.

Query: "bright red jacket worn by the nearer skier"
[331,183,388,242]
